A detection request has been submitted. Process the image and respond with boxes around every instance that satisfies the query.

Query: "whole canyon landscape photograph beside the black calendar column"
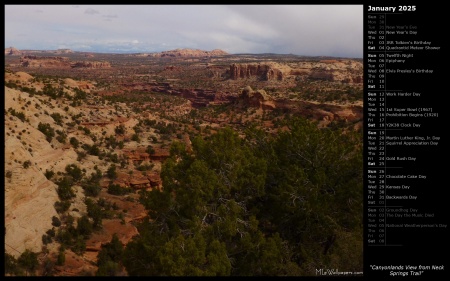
[4,5,364,276]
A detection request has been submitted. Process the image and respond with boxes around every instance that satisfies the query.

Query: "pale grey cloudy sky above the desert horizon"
[5,5,363,58]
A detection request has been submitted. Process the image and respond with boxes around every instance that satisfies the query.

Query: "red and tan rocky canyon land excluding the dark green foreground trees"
[4,47,363,276]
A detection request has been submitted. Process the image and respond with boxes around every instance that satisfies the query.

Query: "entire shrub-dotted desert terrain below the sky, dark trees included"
[4,48,363,276]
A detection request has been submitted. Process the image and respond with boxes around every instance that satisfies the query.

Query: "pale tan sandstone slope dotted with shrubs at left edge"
[4,87,81,256]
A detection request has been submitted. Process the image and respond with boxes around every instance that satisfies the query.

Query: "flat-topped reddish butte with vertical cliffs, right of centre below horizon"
[229,63,283,81]
